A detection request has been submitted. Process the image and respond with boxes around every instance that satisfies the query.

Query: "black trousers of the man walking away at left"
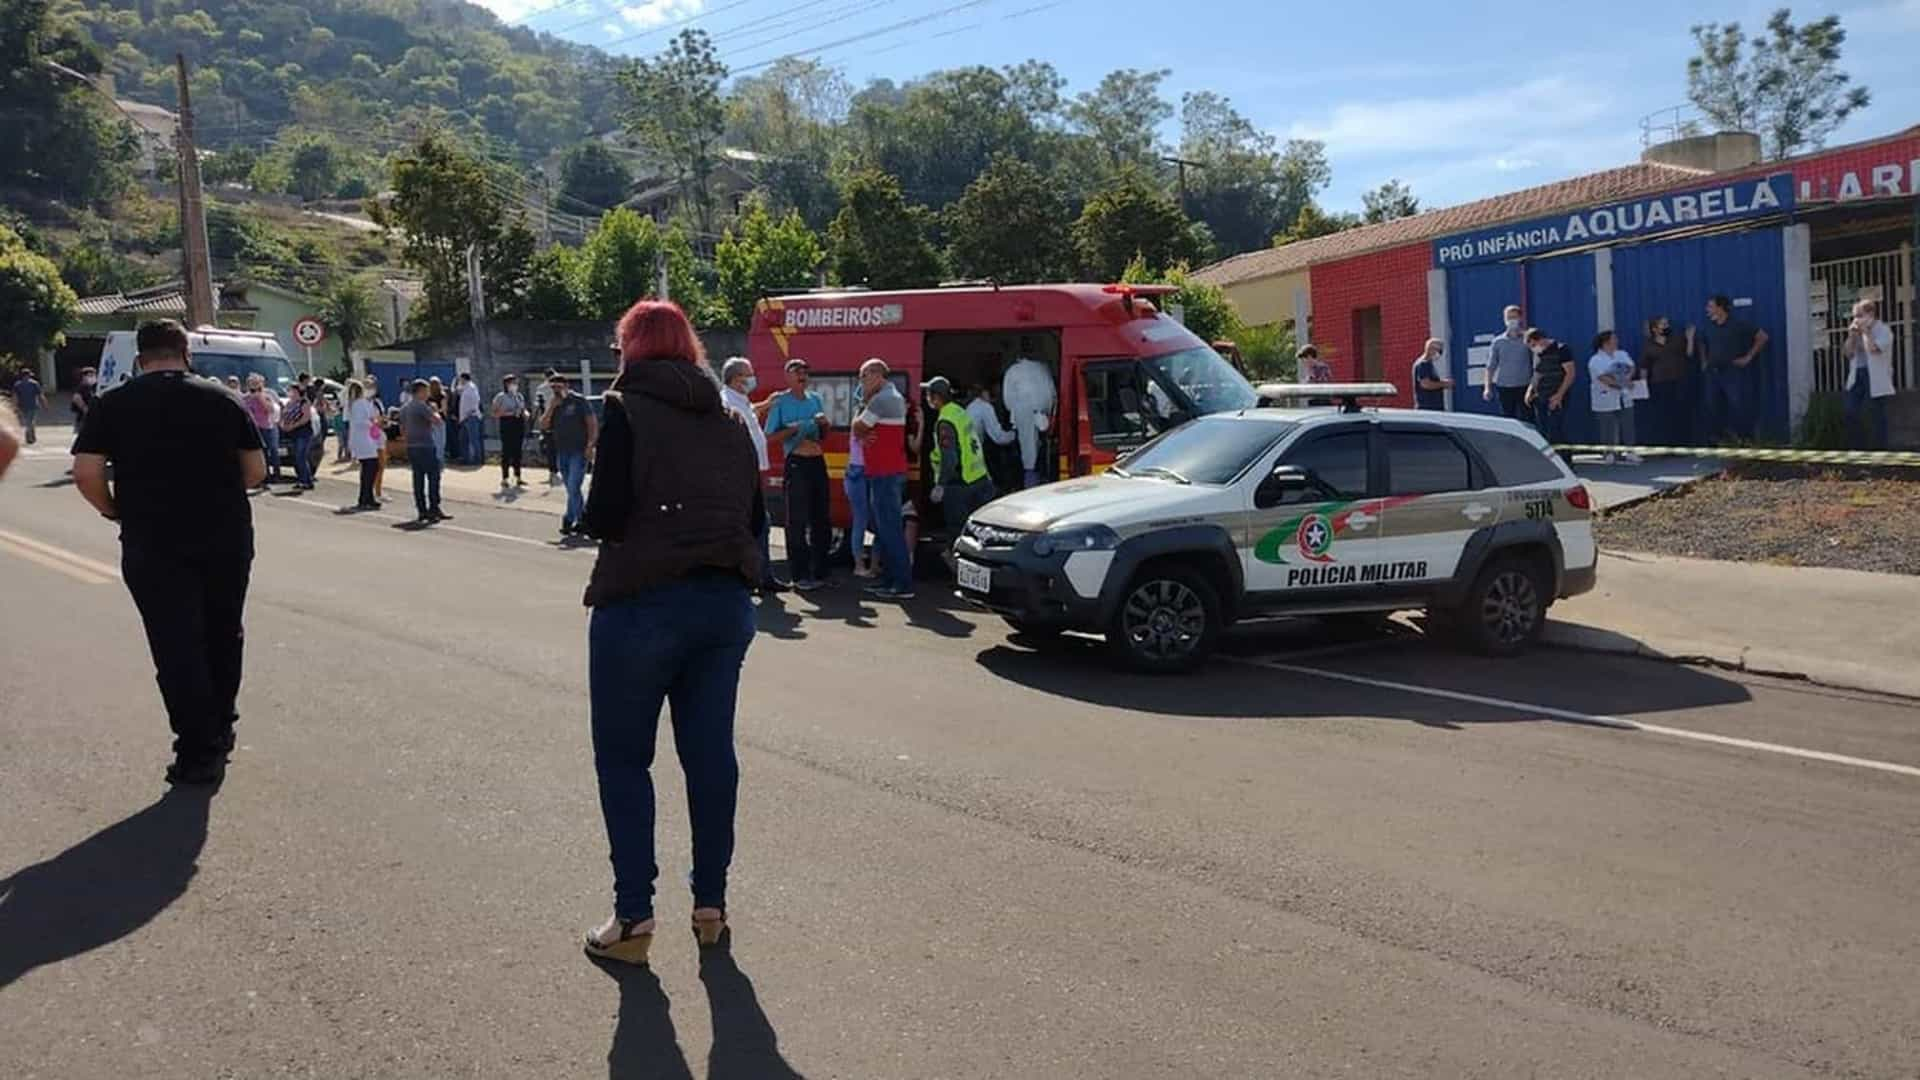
[121,538,253,761]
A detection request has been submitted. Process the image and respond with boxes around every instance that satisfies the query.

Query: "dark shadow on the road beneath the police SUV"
[977,619,1753,730]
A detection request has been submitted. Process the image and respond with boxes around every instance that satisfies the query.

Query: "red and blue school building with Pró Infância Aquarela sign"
[1196,127,1920,448]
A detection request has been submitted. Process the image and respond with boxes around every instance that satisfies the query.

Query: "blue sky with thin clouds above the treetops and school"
[478,0,1920,209]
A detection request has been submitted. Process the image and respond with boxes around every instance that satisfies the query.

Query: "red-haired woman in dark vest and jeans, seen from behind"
[584,300,762,963]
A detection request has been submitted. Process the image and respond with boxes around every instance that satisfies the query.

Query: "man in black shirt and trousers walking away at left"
[73,321,267,784]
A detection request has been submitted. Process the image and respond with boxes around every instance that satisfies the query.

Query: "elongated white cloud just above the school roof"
[1288,77,1611,156]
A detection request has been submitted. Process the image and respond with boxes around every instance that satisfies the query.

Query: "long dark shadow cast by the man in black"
[0,788,213,988]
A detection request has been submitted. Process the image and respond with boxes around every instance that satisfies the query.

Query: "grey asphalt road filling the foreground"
[0,441,1920,1080]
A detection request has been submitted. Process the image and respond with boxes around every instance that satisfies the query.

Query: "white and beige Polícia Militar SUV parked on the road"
[954,382,1597,671]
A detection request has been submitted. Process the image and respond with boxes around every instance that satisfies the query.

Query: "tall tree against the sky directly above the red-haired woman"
[620,29,726,233]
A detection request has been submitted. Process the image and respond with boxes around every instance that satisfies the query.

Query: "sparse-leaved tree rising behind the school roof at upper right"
[1686,8,1872,160]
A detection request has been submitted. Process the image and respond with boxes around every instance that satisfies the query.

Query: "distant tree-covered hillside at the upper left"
[56,0,616,160]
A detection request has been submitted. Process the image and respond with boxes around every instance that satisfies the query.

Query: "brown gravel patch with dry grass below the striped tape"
[1597,465,1920,575]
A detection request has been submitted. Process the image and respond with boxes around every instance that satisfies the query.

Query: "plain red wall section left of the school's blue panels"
[1311,242,1434,407]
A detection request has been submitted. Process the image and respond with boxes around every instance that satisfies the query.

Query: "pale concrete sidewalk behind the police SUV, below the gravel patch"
[1546,552,1920,698]
